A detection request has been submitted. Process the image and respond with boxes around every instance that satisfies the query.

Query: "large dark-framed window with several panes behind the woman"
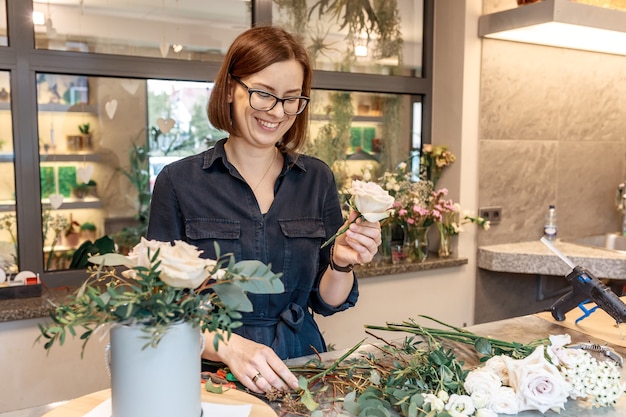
[0,0,433,286]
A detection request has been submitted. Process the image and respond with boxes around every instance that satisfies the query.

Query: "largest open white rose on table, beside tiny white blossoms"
[505,346,570,413]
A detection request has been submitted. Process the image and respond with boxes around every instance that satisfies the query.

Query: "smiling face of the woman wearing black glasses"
[229,60,304,147]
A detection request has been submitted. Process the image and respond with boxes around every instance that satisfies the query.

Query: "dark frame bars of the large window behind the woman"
[0,0,434,287]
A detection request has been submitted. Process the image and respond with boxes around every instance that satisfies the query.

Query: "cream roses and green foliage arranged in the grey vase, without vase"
[39,238,284,349]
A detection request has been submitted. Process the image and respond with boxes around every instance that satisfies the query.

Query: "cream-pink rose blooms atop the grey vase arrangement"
[125,238,215,289]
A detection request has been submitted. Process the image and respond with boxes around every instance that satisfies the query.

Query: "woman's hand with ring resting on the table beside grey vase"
[202,333,298,393]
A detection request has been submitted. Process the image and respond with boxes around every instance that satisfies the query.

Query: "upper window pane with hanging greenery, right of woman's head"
[272,0,424,77]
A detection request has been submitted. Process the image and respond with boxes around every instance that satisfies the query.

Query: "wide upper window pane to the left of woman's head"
[33,0,251,62]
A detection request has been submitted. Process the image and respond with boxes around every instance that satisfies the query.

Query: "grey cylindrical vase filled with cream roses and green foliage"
[38,238,283,417]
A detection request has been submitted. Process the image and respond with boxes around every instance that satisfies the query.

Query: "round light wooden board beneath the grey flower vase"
[43,386,277,417]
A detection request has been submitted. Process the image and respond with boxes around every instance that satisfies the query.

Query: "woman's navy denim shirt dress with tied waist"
[147,139,358,359]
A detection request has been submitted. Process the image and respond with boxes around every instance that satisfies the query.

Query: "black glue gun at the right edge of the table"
[551,266,626,324]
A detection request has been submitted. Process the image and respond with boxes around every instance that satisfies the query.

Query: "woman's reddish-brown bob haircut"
[208,26,313,152]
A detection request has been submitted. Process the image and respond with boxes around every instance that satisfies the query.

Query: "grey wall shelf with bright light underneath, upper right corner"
[478,0,626,55]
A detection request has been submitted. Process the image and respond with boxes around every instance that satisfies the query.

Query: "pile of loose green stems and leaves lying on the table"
[268,316,548,417]
